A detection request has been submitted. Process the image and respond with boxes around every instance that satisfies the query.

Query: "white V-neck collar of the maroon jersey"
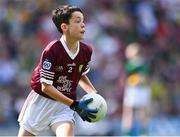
[60,36,79,59]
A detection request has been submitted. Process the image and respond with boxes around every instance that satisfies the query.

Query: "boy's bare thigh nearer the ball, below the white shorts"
[51,122,74,137]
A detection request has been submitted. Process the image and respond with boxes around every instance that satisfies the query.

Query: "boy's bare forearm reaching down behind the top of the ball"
[79,75,97,93]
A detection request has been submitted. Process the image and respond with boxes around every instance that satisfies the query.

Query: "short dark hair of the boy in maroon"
[52,5,82,33]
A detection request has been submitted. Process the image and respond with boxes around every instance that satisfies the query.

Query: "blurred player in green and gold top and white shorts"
[122,42,151,136]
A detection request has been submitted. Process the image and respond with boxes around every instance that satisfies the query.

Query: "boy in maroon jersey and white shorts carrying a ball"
[18,5,97,137]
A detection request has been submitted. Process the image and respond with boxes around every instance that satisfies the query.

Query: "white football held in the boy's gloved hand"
[81,93,107,122]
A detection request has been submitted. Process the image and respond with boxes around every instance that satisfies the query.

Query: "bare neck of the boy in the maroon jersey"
[63,35,79,53]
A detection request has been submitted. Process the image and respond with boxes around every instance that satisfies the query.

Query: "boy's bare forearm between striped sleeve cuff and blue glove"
[42,82,74,106]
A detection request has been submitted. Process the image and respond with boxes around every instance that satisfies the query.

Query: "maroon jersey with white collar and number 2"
[31,36,92,99]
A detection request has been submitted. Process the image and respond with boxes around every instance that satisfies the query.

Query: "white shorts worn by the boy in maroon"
[18,91,75,135]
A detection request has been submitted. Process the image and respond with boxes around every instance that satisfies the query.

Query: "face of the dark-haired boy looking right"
[67,11,85,40]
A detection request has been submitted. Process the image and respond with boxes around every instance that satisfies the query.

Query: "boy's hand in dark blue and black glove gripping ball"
[70,98,97,122]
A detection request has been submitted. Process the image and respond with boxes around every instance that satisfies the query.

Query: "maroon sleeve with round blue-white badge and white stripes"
[39,46,55,85]
